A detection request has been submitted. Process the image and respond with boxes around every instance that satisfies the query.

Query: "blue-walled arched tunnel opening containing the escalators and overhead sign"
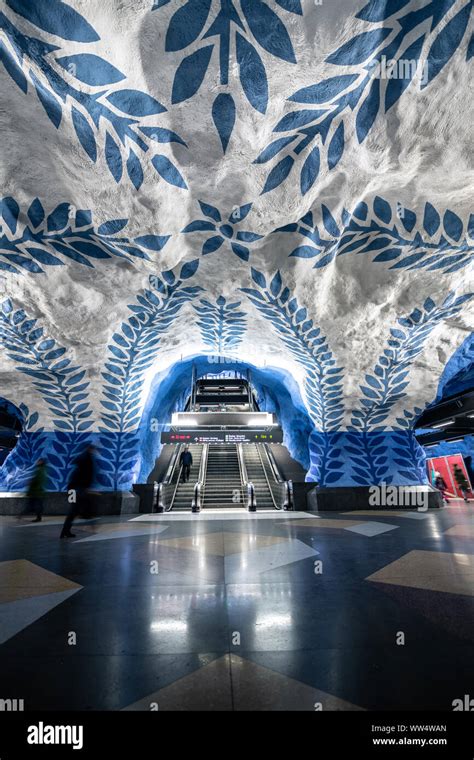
[134,356,313,509]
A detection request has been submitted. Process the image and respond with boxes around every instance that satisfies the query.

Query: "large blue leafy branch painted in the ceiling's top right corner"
[254,0,474,195]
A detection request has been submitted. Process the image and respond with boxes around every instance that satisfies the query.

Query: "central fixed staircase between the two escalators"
[202,443,244,509]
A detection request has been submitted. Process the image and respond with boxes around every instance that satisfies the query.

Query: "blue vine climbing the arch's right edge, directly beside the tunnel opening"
[242,268,344,484]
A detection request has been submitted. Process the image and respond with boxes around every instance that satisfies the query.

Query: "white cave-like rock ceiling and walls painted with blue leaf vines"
[0,0,474,489]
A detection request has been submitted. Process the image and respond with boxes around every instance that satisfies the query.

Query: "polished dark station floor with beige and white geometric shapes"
[0,502,474,711]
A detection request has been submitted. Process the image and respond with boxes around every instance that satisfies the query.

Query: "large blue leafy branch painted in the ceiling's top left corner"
[0,0,187,190]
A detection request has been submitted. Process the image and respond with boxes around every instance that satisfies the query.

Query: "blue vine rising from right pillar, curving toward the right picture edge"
[346,293,474,485]
